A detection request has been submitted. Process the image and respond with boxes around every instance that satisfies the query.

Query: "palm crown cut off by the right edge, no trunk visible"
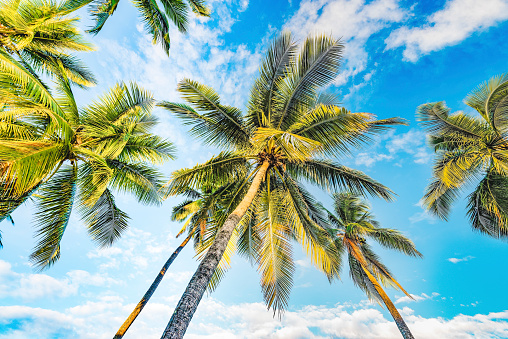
[417,74,508,239]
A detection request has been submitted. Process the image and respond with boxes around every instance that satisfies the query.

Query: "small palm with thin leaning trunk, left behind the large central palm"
[114,183,231,339]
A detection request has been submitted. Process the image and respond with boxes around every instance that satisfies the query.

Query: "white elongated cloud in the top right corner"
[385,0,508,62]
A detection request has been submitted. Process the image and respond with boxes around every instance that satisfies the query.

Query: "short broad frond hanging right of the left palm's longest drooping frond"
[80,189,129,247]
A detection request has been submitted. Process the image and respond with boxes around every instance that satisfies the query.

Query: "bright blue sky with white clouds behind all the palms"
[0,0,508,338]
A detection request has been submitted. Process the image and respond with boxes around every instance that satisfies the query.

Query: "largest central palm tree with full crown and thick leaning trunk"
[160,33,402,338]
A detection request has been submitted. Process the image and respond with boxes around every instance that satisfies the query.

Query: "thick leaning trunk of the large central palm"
[161,161,270,339]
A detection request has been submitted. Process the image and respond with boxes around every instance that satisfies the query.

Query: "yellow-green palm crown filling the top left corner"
[0,0,95,86]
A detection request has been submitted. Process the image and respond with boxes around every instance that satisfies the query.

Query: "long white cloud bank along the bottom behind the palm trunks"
[0,296,508,339]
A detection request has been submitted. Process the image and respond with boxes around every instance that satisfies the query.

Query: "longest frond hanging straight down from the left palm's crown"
[30,166,77,269]
